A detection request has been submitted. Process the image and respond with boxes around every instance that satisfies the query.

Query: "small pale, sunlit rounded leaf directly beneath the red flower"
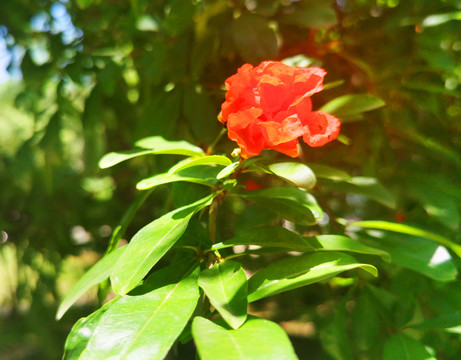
[268,162,316,190]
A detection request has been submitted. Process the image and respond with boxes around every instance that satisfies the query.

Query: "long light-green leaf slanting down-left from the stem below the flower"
[110,194,214,295]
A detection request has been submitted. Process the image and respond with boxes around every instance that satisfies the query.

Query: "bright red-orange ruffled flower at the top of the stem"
[219,61,341,158]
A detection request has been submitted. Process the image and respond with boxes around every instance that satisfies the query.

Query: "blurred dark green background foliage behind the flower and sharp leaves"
[0,0,461,360]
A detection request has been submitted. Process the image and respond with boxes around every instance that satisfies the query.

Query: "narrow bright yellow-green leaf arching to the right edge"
[347,220,461,257]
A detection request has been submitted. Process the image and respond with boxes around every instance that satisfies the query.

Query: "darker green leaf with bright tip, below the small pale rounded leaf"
[239,187,323,225]
